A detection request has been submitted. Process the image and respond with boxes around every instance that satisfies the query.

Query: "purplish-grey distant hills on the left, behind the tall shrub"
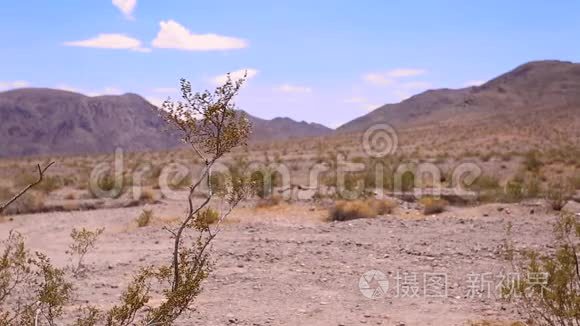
[0,88,331,157]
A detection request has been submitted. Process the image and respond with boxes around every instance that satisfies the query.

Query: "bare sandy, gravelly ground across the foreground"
[0,203,572,325]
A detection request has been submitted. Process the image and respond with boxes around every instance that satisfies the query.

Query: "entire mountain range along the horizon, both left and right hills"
[0,61,580,157]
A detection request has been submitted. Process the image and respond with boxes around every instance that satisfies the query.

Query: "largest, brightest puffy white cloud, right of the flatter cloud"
[152,20,248,51]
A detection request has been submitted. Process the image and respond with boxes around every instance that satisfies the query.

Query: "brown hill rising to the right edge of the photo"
[337,61,580,134]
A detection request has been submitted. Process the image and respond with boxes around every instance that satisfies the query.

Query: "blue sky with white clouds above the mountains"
[0,0,580,127]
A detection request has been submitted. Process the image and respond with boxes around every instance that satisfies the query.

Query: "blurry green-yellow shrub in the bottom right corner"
[502,213,580,326]
